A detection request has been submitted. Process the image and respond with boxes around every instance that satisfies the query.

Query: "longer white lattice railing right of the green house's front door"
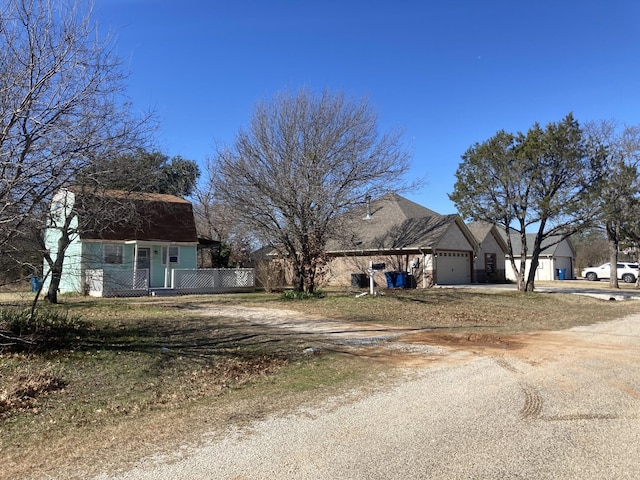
[171,268,255,294]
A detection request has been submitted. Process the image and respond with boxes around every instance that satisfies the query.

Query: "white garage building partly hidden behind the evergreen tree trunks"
[500,229,575,281]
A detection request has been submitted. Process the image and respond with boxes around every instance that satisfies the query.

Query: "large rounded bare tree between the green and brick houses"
[210,89,409,292]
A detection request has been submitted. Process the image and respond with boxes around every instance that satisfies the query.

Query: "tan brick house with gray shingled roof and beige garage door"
[327,194,477,287]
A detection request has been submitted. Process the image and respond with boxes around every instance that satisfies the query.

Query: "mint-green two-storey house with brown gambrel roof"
[45,189,253,296]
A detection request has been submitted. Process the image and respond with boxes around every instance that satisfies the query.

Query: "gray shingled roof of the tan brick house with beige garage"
[328,193,466,253]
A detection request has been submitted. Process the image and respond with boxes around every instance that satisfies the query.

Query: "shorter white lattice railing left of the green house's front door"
[85,269,149,297]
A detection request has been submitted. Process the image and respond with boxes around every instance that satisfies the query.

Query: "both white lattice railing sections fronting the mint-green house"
[85,268,255,297]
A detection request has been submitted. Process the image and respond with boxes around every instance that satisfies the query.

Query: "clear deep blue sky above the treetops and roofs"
[94,0,640,214]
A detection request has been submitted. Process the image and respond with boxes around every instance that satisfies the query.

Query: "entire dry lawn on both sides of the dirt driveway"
[0,289,640,478]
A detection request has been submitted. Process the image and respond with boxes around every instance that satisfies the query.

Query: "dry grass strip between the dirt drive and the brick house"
[258,288,640,333]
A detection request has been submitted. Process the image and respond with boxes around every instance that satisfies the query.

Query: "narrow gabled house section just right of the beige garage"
[468,222,508,283]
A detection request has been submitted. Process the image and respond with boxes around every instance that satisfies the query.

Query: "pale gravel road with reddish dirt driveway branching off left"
[98,307,640,480]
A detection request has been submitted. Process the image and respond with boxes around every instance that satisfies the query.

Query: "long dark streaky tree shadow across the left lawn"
[0,316,330,360]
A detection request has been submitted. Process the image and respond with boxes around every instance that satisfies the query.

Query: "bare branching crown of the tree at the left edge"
[0,0,150,298]
